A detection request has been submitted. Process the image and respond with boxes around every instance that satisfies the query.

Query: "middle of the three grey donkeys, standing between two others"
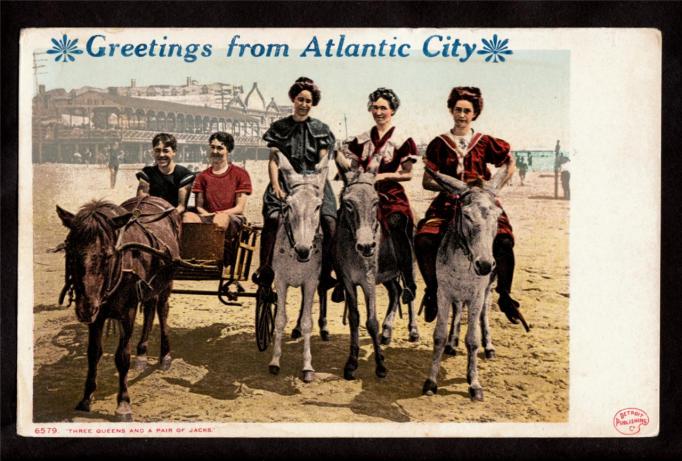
[336,169,419,379]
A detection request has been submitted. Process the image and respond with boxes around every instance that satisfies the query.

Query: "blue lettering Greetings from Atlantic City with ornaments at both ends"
[47,31,513,63]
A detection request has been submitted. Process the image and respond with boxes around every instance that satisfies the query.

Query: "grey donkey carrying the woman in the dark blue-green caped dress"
[269,153,329,382]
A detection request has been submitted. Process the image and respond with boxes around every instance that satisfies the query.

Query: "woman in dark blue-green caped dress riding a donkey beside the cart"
[254,77,336,288]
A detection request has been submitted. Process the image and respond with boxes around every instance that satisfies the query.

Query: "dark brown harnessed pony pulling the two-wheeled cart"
[57,197,180,421]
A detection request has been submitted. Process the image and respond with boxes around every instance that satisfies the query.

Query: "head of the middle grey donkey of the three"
[341,171,379,258]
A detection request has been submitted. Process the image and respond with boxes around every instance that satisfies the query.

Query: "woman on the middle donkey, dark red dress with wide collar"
[344,88,418,303]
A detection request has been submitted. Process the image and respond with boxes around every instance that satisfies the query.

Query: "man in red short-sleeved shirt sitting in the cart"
[183,131,252,260]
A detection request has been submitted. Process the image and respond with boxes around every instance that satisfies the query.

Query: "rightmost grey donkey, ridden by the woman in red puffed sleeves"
[422,168,504,400]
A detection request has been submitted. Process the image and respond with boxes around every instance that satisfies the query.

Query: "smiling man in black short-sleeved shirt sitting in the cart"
[136,133,194,214]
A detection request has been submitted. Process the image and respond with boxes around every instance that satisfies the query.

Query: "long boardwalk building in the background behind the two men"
[33,79,291,163]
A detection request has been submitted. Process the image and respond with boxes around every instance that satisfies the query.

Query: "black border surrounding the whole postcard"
[0,1,682,460]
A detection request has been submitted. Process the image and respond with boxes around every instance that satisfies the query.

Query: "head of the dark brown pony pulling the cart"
[57,201,130,323]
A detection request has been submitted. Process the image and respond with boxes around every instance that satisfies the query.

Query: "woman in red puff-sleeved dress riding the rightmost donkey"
[414,87,519,323]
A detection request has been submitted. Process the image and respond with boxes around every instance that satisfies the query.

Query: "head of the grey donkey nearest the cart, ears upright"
[278,153,329,262]
